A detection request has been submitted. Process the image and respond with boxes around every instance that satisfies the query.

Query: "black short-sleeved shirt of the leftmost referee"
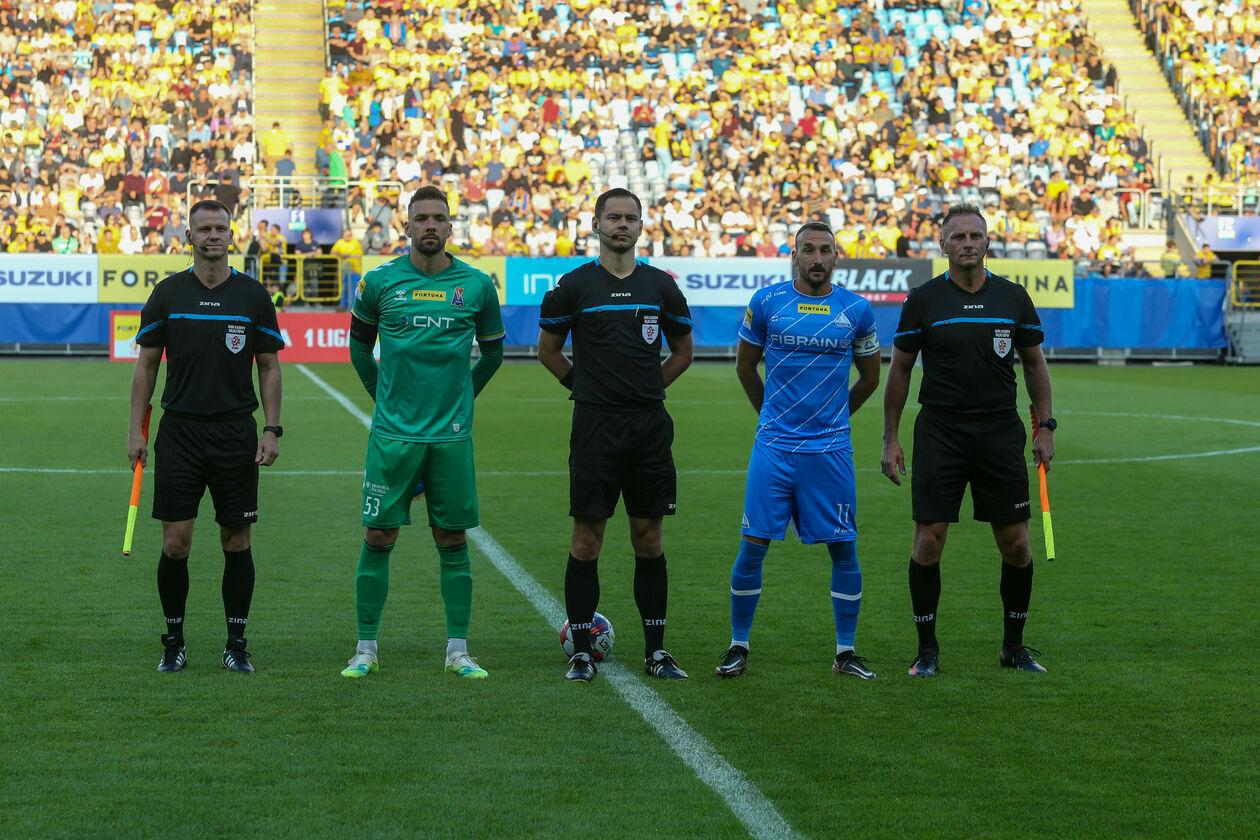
[136,268,285,419]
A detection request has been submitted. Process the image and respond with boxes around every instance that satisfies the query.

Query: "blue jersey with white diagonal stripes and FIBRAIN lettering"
[740,282,879,452]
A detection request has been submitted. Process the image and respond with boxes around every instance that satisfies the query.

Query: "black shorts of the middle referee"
[568,403,678,519]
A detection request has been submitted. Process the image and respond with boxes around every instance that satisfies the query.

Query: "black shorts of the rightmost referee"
[910,406,1031,524]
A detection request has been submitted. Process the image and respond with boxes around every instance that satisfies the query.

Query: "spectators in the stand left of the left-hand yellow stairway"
[0,0,255,254]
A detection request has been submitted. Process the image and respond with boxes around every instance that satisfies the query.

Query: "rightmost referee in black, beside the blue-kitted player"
[881,204,1057,676]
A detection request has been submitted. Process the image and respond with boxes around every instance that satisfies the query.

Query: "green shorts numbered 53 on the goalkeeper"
[363,434,478,530]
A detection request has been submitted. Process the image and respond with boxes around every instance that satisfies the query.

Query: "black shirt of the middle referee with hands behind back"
[538,259,692,408]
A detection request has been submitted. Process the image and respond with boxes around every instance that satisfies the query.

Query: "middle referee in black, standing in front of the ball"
[538,189,692,683]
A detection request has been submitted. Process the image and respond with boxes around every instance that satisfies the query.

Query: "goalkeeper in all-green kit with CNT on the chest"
[341,186,504,679]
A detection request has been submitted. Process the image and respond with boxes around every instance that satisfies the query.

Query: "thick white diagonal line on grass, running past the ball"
[297,364,799,839]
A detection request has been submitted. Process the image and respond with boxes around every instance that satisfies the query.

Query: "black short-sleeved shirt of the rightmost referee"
[892,272,1045,413]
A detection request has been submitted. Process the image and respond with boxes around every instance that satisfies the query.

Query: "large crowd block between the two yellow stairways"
[320,0,1155,269]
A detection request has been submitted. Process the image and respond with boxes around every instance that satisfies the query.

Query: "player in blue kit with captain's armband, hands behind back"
[714,222,879,680]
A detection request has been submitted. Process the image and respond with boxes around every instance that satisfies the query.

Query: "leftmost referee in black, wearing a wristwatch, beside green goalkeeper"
[127,200,285,674]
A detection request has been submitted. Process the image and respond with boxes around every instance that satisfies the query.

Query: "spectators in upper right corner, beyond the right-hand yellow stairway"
[1134,0,1260,185]
